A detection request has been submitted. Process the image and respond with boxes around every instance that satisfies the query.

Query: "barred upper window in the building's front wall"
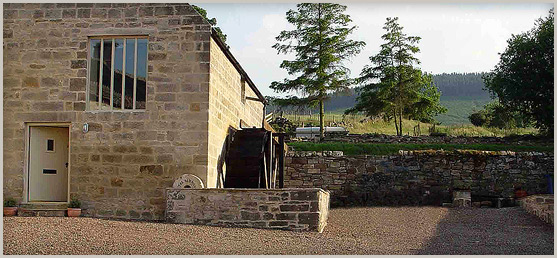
[87,37,147,110]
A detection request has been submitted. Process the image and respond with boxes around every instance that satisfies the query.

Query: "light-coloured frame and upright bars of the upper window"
[85,34,149,112]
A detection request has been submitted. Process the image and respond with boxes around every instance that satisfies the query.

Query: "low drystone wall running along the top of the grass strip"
[323,134,553,145]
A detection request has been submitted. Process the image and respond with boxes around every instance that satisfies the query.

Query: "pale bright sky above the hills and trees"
[195,2,553,96]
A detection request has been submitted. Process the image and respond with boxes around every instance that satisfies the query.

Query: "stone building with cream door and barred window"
[3,3,265,220]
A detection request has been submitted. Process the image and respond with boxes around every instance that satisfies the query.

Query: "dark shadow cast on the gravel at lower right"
[416,207,554,255]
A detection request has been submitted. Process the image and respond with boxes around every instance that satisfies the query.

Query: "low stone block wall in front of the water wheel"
[166,188,329,232]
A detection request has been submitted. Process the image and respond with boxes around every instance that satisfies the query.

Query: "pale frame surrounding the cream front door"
[23,122,72,204]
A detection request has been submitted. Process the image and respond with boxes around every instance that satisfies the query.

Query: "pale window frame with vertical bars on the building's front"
[85,35,149,112]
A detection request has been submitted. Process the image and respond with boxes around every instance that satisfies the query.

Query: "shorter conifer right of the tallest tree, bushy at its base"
[346,17,446,135]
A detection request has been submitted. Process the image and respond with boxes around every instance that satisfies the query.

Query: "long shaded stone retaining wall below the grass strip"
[284,151,554,206]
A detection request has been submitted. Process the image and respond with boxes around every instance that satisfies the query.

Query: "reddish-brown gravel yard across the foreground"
[3,207,553,254]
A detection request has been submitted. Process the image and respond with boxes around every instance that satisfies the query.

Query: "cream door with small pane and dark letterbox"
[29,126,69,202]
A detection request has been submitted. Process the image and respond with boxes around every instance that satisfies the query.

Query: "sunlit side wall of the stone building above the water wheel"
[207,39,263,187]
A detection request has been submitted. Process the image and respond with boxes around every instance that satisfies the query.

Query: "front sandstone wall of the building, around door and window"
[3,3,211,219]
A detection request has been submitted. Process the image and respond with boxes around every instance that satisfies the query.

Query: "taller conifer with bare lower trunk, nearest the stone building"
[270,3,365,138]
